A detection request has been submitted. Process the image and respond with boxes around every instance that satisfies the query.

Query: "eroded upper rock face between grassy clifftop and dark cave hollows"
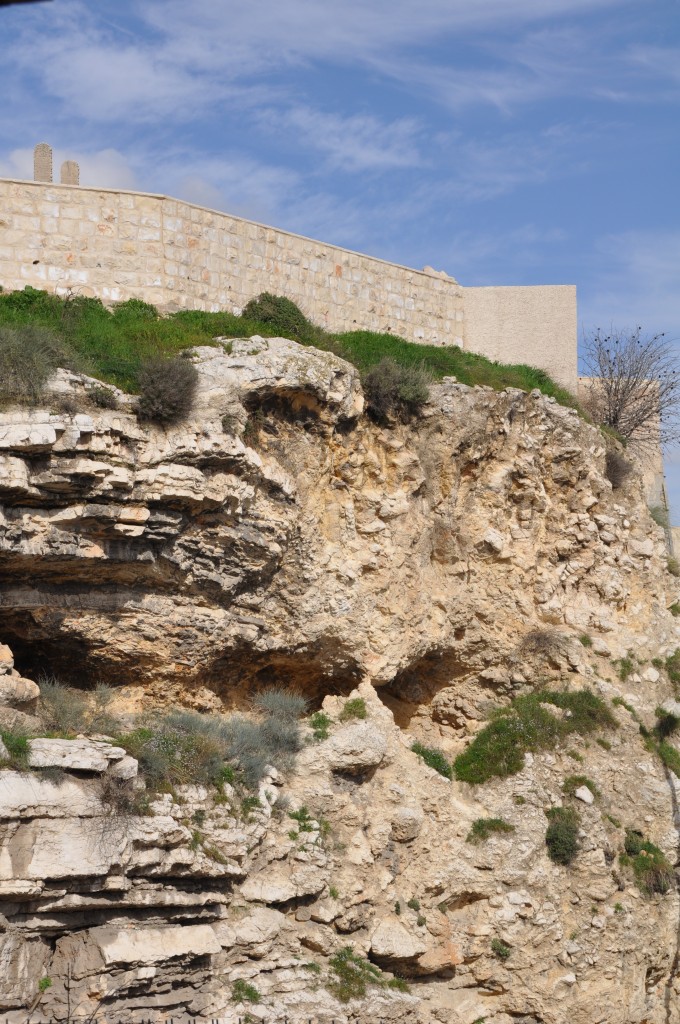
[0,339,675,725]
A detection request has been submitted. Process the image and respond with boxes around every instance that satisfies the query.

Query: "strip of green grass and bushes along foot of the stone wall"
[0,288,576,407]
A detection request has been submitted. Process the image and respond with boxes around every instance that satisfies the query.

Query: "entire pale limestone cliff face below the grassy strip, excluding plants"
[0,338,680,1024]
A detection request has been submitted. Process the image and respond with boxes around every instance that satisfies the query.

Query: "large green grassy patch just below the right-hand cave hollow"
[454,689,617,784]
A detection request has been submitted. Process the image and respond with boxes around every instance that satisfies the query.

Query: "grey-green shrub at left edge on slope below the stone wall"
[0,326,74,407]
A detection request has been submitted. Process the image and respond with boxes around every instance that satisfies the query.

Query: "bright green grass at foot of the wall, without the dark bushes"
[0,288,576,406]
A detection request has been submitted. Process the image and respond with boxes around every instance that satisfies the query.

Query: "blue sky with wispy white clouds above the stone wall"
[0,0,680,512]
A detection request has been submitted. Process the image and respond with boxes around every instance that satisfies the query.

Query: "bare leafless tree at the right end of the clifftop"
[584,327,680,450]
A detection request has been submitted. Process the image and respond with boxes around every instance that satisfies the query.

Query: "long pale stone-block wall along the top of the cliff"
[0,180,577,387]
